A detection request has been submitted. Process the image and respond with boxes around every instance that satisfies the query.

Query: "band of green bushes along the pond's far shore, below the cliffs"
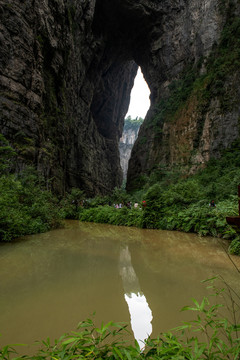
[0,131,240,255]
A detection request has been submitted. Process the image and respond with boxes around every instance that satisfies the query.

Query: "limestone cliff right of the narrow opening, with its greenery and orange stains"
[127,0,240,190]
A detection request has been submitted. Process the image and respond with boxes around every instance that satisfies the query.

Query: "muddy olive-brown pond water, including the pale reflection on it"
[0,221,240,345]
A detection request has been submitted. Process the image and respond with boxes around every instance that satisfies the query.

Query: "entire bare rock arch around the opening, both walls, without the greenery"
[0,0,240,196]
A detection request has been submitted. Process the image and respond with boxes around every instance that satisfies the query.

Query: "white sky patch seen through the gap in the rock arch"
[125,67,150,119]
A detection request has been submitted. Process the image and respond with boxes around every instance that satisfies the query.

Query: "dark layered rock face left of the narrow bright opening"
[0,0,137,196]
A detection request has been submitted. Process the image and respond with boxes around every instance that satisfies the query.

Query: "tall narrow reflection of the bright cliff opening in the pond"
[119,245,153,347]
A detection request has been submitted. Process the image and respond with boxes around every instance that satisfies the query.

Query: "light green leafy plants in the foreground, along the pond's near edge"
[0,278,240,360]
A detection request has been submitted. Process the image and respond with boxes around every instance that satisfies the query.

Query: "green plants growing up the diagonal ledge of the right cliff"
[147,10,240,141]
